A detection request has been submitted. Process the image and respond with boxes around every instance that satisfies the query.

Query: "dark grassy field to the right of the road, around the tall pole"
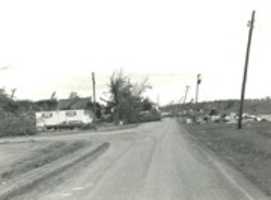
[184,119,271,196]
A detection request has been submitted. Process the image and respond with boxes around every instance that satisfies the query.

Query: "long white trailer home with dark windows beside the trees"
[36,109,94,129]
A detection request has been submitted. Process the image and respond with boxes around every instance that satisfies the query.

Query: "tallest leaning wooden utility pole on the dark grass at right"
[238,10,255,129]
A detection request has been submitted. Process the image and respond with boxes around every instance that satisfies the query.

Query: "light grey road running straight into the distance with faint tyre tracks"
[9,120,266,200]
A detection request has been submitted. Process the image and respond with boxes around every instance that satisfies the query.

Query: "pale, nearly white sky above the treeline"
[0,0,271,105]
